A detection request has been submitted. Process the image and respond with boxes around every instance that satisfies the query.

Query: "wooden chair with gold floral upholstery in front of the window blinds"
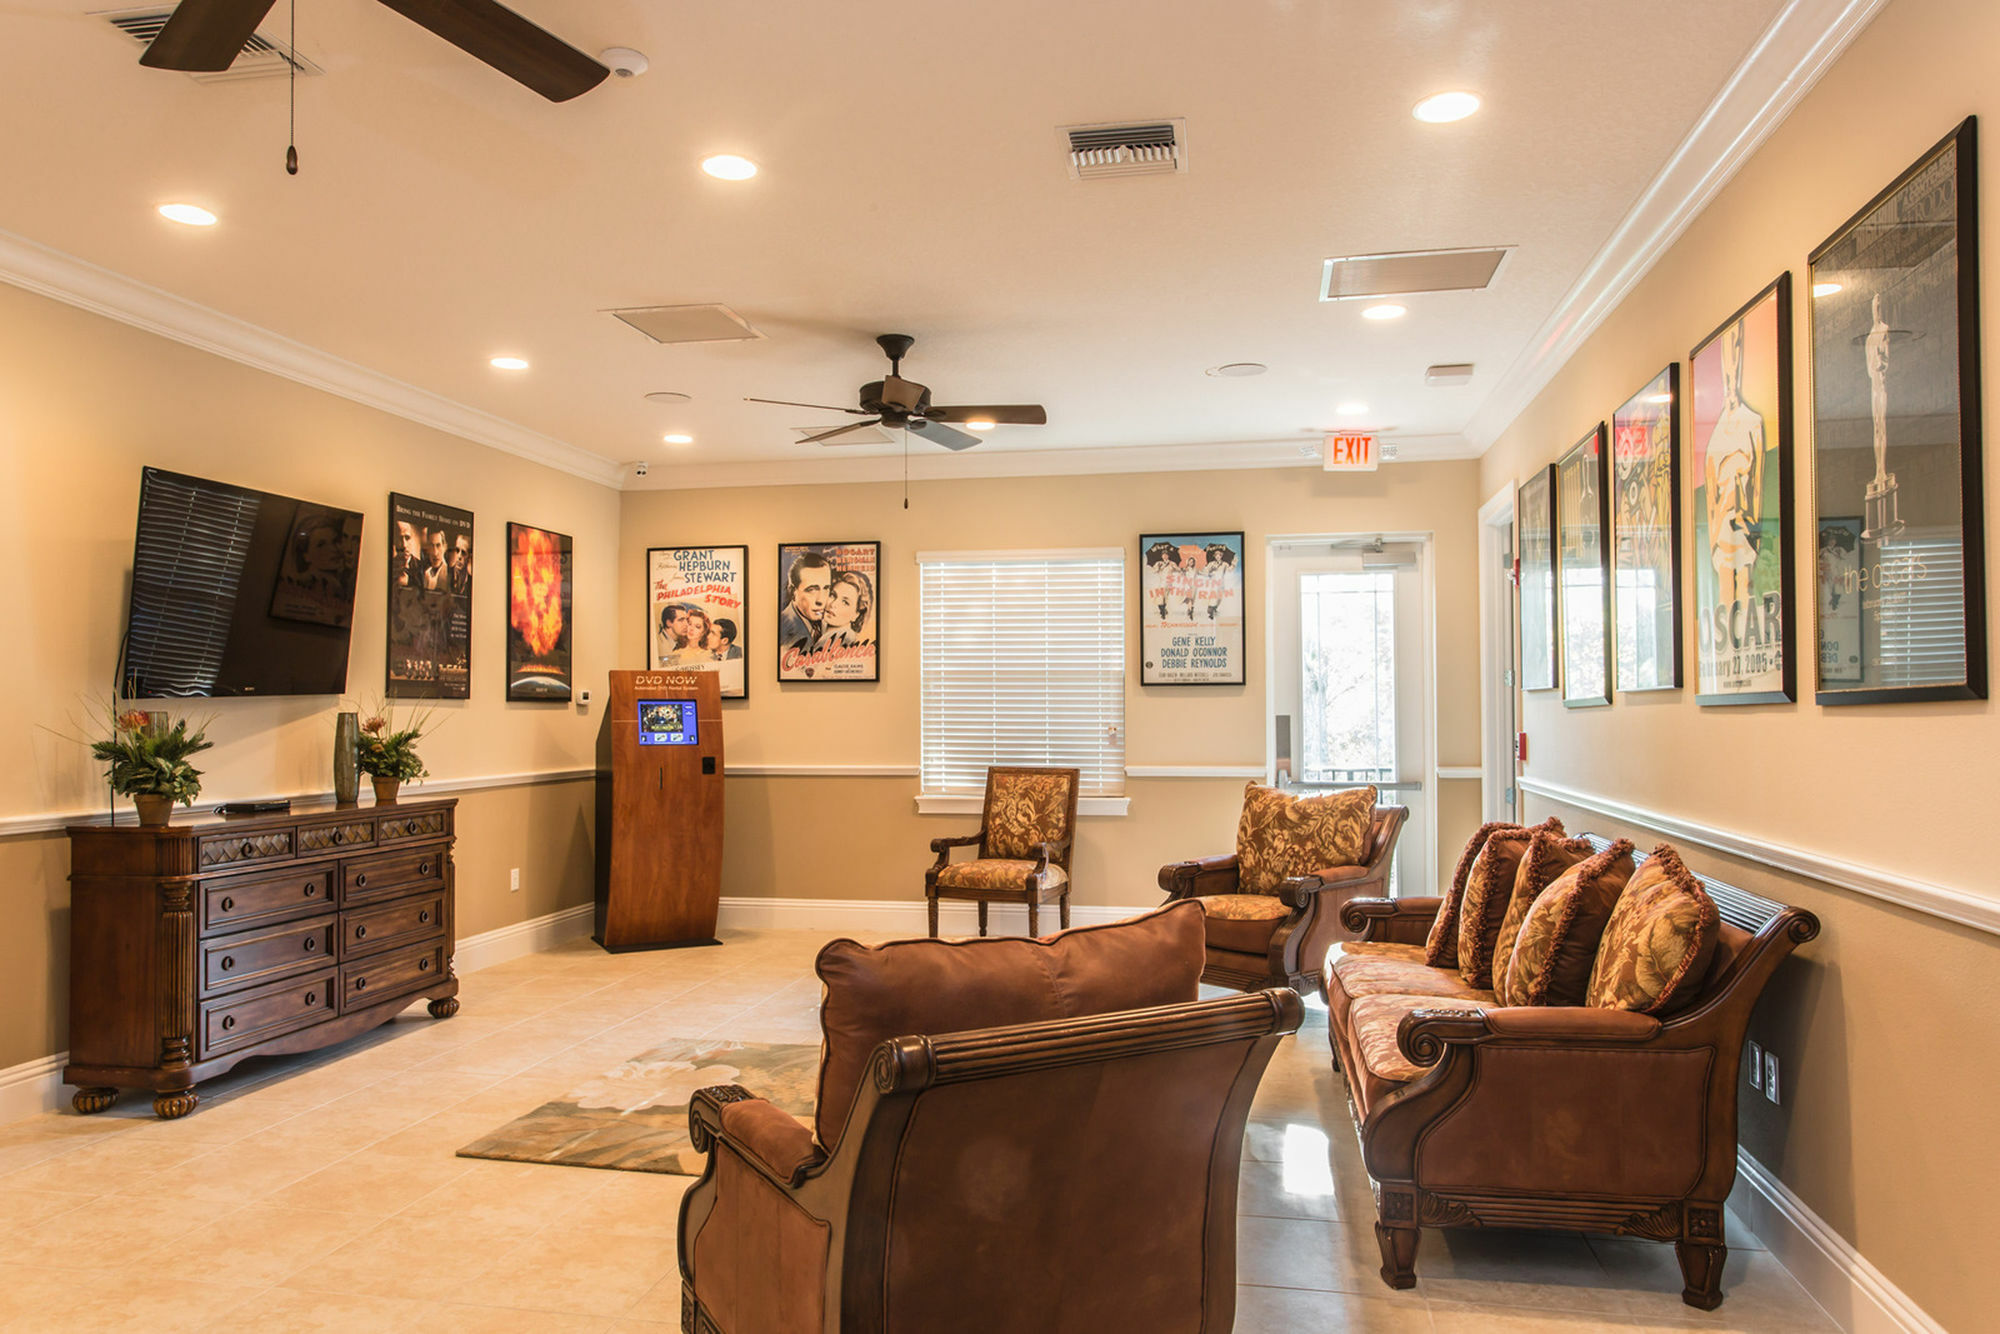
[924,768,1082,936]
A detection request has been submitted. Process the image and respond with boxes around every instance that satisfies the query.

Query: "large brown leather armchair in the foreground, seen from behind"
[678,904,1302,1334]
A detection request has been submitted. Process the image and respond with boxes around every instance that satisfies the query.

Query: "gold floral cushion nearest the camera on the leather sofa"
[1584,844,1722,1014]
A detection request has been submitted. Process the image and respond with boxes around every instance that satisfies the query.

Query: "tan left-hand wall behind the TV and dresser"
[0,286,618,1068]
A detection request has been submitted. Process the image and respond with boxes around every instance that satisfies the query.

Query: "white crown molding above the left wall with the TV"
[0,232,620,488]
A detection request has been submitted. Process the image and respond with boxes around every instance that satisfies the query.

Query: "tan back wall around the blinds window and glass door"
[618,462,1478,904]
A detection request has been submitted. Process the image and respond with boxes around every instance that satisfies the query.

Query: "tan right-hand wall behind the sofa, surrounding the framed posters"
[1480,0,2000,1330]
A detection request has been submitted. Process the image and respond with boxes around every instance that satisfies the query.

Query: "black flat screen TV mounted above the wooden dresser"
[118,468,362,700]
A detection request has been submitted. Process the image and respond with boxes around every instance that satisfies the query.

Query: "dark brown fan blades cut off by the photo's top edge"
[138,0,610,102]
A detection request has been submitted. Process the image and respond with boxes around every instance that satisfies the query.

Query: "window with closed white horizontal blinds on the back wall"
[916,548,1126,796]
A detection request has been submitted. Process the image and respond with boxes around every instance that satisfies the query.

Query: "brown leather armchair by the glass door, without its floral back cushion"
[1160,806,1410,992]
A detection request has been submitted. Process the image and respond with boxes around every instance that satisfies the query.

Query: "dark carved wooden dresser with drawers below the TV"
[62,800,458,1118]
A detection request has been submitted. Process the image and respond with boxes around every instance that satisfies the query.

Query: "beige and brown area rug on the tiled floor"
[458,1038,820,1176]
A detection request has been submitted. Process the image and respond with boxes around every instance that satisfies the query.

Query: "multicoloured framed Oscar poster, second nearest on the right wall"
[1686,270,1798,706]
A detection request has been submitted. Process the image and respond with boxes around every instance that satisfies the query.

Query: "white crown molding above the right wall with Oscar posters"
[1464,0,1888,454]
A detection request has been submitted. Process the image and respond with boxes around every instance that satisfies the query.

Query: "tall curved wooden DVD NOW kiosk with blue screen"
[596,672,722,952]
